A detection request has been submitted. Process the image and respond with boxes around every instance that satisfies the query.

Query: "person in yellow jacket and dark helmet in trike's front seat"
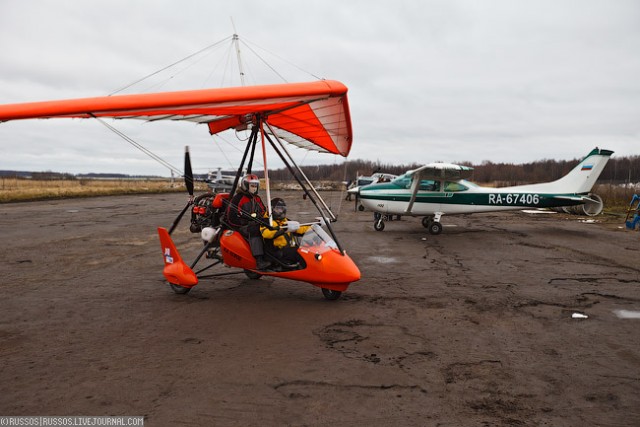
[260,197,311,268]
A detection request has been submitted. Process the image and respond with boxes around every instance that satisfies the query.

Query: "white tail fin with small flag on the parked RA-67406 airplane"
[502,147,613,194]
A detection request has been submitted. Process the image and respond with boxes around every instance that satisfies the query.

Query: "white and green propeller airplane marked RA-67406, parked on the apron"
[357,147,613,235]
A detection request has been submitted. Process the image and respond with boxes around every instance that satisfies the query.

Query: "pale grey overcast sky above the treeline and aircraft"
[0,0,640,176]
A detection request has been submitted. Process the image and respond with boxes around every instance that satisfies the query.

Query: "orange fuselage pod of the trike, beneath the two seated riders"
[220,230,360,292]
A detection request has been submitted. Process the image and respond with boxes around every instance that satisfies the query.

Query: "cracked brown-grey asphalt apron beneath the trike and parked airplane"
[0,192,640,426]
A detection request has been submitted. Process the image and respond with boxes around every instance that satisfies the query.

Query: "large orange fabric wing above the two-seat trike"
[0,80,352,157]
